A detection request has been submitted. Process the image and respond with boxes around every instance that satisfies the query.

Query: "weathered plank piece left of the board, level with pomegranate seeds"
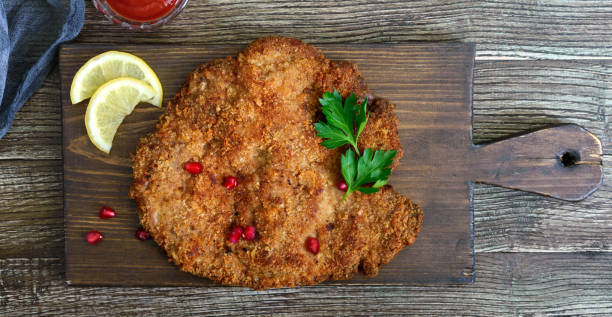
[0,160,64,258]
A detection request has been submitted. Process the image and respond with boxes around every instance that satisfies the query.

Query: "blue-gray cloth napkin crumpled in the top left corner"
[0,0,85,138]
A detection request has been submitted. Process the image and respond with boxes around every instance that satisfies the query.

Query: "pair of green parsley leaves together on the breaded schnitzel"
[314,90,397,201]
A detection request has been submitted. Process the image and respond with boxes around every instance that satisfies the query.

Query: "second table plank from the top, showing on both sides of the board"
[0,60,612,159]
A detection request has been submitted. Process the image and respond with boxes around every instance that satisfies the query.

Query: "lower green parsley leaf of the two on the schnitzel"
[340,148,397,201]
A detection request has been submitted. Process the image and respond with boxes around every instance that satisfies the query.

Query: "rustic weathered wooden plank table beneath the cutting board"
[0,0,612,316]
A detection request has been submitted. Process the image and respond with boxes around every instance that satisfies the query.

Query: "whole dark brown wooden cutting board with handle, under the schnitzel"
[60,43,602,286]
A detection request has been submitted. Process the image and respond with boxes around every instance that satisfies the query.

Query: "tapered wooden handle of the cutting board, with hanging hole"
[471,125,603,201]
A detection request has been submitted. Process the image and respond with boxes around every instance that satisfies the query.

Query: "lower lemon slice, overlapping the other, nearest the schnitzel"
[85,77,156,153]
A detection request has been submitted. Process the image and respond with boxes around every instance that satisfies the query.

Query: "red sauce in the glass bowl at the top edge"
[106,0,179,22]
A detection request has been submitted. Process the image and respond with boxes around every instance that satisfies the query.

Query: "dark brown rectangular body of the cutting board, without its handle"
[60,43,474,286]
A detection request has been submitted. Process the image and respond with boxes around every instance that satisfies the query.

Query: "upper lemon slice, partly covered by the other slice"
[70,51,163,107]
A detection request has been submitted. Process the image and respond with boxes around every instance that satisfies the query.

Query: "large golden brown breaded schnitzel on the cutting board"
[130,38,423,289]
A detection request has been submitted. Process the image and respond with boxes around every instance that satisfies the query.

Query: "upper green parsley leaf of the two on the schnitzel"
[314,90,369,153]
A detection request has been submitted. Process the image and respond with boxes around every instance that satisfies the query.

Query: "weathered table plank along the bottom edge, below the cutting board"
[0,253,612,316]
